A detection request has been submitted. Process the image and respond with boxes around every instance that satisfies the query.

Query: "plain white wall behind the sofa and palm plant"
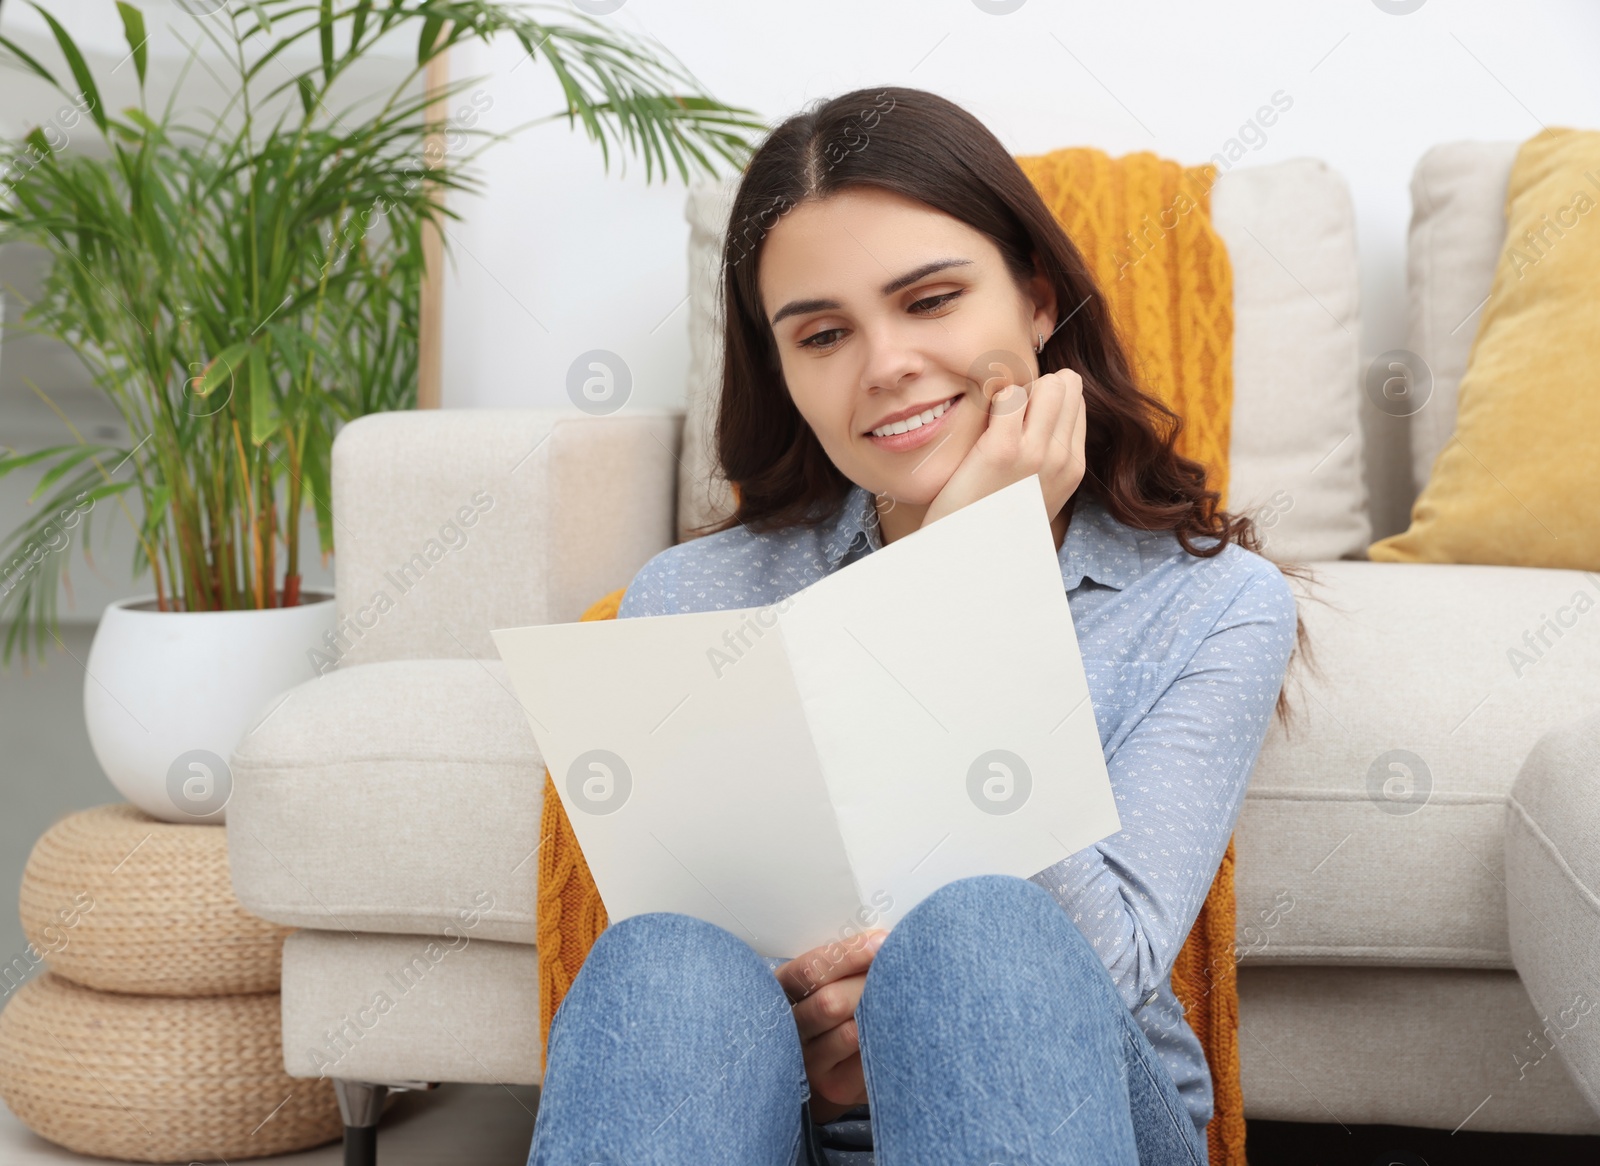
[0,0,1600,619]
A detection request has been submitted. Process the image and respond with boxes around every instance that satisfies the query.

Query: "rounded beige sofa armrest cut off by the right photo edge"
[1506,703,1600,1113]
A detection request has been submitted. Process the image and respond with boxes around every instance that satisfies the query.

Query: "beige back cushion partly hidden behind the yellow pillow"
[1406,142,1518,491]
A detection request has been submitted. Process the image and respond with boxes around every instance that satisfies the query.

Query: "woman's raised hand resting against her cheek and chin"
[922,368,1085,526]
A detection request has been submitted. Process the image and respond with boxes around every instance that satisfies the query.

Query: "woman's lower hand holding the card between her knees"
[774,931,888,1124]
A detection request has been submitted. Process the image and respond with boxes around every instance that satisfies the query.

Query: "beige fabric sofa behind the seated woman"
[227,142,1600,1158]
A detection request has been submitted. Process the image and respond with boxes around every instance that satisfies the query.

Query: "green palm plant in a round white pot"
[0,0,762,821]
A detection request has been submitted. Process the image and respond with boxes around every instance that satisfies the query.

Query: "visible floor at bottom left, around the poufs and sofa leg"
[0,1084,539,1166]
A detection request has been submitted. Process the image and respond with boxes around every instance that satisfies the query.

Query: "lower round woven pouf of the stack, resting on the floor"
[0,978,344,1163]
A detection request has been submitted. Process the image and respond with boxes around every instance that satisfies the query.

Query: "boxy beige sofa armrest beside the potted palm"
[331,409,683,672]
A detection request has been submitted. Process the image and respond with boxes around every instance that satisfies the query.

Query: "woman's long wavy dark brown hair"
[690,86,1314,723]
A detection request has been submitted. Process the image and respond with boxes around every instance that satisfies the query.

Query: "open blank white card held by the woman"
[493,475,1122,956]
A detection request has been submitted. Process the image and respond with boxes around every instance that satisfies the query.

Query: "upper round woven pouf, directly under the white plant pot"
[19,805,293,996]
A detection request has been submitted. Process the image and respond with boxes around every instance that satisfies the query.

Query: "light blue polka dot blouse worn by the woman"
[618,486,1296,1129]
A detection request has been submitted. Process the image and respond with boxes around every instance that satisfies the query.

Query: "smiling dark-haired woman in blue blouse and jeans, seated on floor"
[530,88,1299,1166]
